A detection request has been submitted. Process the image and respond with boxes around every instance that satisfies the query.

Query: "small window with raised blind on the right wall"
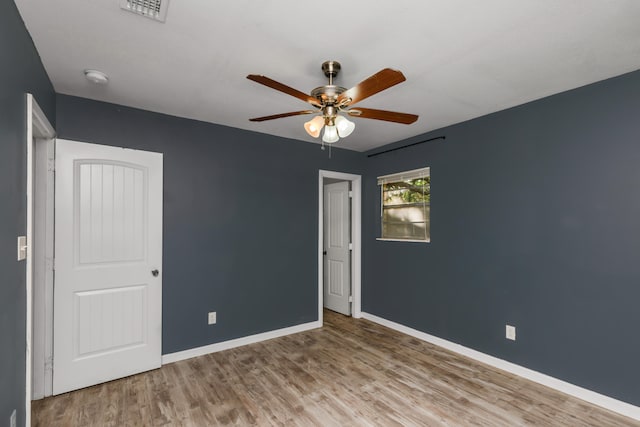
[378,168,431,242]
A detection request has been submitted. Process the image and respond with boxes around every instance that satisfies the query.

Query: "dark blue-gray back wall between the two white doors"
[57,95,364,354]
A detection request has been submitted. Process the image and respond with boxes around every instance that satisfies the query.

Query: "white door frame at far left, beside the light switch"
[25,93,55,425]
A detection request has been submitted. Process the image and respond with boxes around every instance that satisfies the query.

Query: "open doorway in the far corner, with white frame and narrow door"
[318,170,362,322]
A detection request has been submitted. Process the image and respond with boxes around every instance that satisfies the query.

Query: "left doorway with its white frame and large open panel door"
[25,100,163,408]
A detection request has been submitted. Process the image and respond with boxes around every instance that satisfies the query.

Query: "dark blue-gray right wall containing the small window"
[363,72,640,405]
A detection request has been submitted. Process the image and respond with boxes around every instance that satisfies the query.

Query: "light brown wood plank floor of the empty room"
[33,312,640,427]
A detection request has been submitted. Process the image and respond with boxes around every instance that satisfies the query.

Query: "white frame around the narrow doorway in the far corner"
[318,169,362,324]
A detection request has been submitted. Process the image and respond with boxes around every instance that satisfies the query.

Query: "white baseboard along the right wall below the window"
[362,312,640,421]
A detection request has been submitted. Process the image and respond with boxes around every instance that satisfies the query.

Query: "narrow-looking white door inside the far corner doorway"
[323,181,351,316]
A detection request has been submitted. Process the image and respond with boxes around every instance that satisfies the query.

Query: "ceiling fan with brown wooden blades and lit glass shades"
[247,61,418,144]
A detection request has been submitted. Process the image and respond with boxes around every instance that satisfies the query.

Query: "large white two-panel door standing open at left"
[53,140,162,394]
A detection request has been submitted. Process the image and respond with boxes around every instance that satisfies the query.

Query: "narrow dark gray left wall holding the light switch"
[0,1,55,425]
